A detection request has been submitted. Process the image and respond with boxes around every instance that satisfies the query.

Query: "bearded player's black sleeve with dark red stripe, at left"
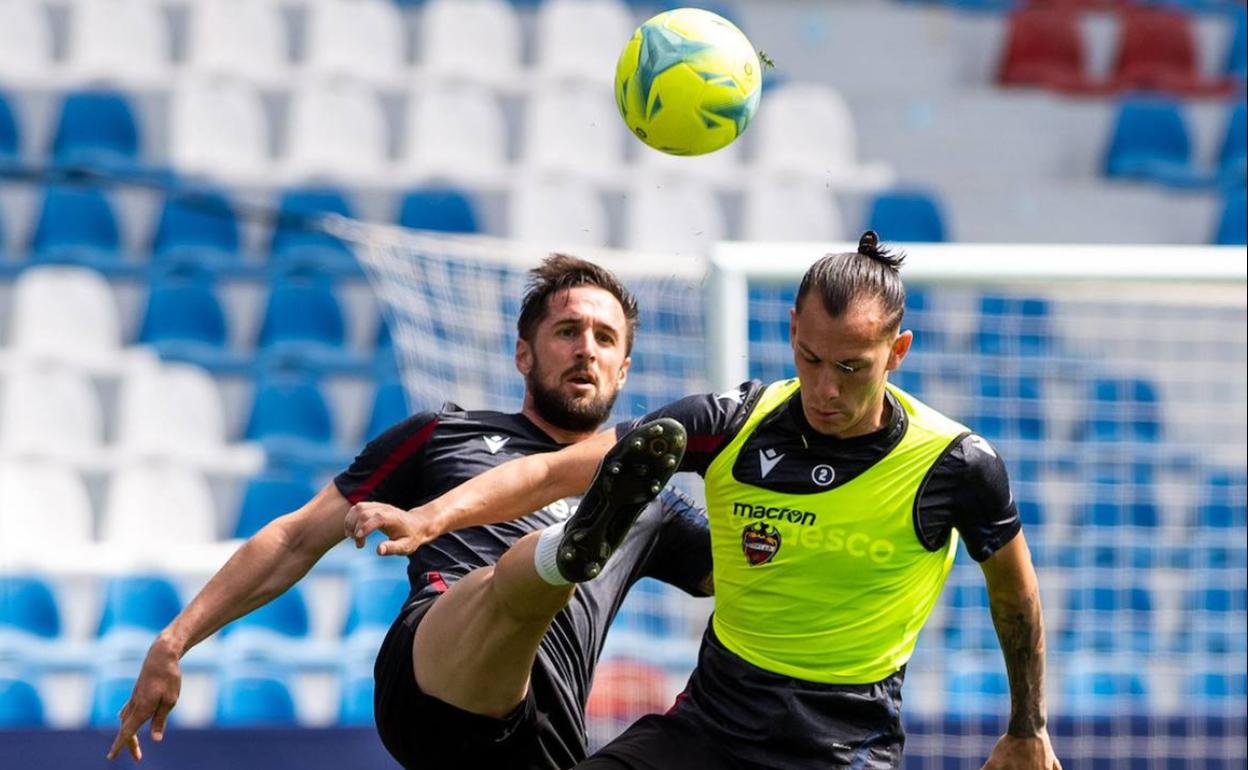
[333,412,438,508]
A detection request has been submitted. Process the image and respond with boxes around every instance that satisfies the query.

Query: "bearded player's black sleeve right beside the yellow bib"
[645,484,711,597]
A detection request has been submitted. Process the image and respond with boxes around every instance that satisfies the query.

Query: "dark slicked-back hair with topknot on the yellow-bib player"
[795,230,906,329]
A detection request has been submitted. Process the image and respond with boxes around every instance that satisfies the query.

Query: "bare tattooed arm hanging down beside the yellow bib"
[981,533,1061,770]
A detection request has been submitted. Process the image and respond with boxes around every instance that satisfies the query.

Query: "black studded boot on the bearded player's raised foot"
[555,417,685,583]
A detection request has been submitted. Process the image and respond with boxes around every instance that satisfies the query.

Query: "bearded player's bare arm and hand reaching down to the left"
[109,484,351,761]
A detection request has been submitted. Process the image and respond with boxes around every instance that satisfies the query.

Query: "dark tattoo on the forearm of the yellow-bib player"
[990,592,1046,738]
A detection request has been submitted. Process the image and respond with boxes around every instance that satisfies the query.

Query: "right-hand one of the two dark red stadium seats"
[1112,6,1234,96]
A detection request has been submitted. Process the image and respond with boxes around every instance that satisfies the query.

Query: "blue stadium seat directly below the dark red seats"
[1104,97,1213,187]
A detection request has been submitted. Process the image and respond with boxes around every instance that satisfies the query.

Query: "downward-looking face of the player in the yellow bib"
[789,296,912,438]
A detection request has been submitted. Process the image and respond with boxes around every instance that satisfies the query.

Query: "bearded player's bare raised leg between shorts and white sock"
[412,533,574,719]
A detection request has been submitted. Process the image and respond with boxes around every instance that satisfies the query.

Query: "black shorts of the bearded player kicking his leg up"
[373,598,585,770]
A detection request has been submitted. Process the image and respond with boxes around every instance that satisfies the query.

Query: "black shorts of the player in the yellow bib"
[577,629,906,770]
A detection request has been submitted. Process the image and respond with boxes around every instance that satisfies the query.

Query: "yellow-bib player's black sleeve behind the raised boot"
[615,379,764,474]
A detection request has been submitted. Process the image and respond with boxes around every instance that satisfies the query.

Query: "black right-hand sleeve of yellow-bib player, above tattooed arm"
[915,433,1022,562]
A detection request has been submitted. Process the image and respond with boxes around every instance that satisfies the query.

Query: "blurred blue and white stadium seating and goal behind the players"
[0,0,1248,768]
